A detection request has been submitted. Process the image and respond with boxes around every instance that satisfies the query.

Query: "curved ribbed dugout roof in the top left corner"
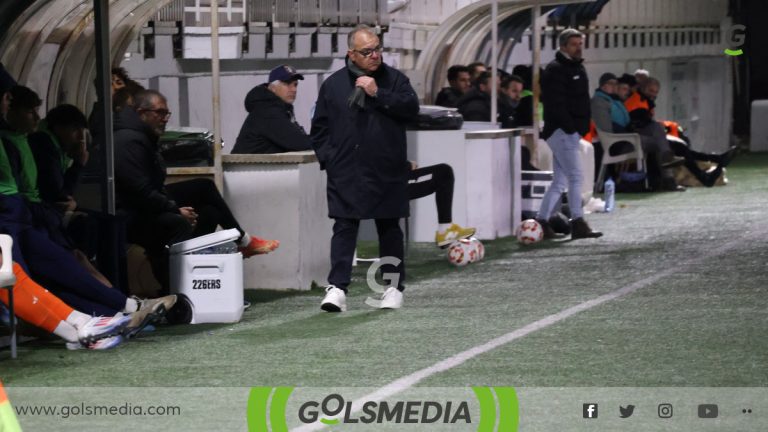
[0,0,176,108]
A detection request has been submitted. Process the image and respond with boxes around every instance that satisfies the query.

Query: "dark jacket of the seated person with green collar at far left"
[28,131,83,204]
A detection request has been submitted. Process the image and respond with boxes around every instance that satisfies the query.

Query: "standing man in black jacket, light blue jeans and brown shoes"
[536,29,602,239]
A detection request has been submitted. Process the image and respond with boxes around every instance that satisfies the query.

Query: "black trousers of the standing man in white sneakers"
[328,218,405,292]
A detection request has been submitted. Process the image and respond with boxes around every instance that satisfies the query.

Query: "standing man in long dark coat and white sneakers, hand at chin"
[311,26,419,312]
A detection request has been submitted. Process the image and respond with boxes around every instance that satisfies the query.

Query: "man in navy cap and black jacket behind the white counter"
[232,65,312,154]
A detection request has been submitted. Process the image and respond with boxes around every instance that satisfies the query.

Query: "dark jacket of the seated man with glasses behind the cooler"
[114,108,179,217]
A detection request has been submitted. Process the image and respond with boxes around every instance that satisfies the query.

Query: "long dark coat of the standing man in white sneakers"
[310,60,419,219]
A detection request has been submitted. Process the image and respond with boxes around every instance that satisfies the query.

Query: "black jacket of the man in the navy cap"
[232,84,312,154]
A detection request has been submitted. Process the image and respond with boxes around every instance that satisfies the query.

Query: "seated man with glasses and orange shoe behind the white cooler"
[114,90,279,290]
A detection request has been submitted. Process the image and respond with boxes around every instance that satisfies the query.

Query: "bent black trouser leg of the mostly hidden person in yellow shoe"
[408,164,454,223]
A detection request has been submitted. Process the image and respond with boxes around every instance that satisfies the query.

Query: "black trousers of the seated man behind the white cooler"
[128,179,245,290]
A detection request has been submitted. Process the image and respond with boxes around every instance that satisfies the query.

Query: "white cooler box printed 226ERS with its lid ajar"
[170,229,243,324]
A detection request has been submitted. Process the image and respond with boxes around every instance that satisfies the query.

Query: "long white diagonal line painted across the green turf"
[292,230,752,432]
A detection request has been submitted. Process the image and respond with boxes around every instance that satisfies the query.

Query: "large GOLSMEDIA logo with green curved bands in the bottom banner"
[248,387,519,432]
